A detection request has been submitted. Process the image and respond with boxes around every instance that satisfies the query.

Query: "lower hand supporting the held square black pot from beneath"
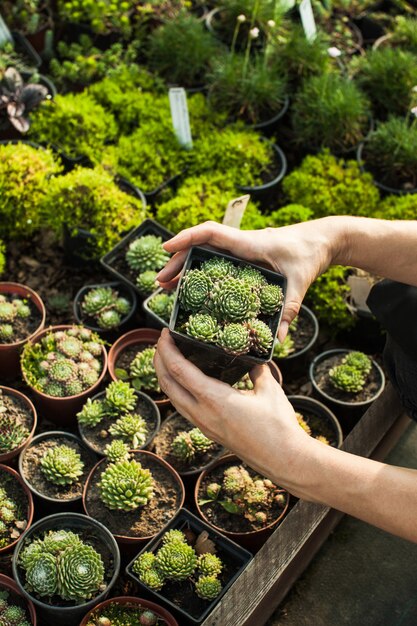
[154,329,313,488]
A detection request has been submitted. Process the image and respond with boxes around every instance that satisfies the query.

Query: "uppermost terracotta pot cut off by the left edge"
[0,283,46,378]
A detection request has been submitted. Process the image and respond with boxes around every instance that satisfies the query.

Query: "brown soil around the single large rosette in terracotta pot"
[86,454,181,537]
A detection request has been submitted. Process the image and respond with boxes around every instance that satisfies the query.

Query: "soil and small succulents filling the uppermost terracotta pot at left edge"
[0,294,42,344]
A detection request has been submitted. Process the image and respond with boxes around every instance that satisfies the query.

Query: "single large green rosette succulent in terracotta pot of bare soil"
[99,460,153,511]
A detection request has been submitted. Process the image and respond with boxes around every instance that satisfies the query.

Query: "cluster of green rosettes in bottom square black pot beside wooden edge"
[132,529,224,601]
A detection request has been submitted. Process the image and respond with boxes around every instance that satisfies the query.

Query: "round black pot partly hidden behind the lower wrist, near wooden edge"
[287,396,343,448]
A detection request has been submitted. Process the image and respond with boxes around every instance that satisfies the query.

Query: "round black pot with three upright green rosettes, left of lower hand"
[77,380,161,456]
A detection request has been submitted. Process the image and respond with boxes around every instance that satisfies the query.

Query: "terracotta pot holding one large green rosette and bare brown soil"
[83,447,185,545]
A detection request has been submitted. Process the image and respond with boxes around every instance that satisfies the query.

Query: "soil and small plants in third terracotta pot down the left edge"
[0,467,28,548]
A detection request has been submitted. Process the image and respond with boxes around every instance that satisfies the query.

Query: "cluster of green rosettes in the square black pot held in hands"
[179,257,283,356]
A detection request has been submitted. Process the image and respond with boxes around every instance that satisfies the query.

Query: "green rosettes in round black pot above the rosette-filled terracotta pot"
[80,287,132,330]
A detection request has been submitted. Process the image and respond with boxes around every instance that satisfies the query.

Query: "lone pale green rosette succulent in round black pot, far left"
[40,445,84,486]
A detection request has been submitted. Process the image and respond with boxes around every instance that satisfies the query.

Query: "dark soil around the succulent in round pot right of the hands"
[313,353,381,402]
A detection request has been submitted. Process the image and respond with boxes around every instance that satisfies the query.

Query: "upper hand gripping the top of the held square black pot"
[157,218,333,342]
